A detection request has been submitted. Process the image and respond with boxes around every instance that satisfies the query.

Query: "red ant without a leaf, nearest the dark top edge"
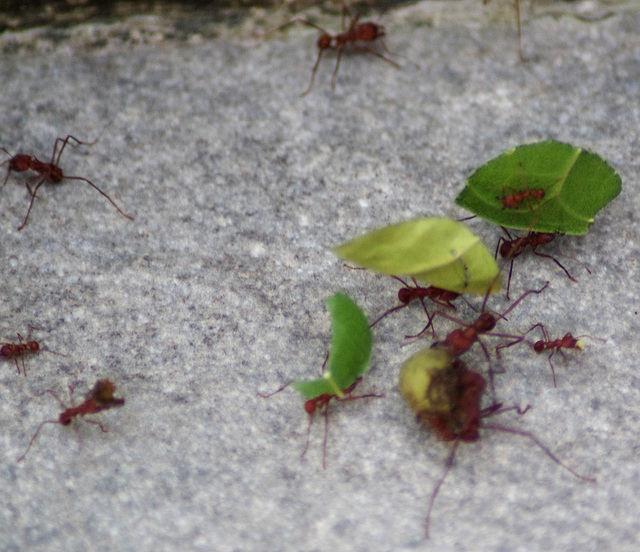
[276,4,402,96]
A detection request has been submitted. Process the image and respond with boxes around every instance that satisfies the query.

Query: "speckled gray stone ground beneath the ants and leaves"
[0,0,640,552]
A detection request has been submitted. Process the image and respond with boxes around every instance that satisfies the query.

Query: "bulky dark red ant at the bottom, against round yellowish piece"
[410,359,595,538]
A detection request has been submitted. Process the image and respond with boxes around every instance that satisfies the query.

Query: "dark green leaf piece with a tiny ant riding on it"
[456,140,622,235]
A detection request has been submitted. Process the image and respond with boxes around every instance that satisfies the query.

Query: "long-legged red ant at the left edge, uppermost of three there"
[0,134,133,231]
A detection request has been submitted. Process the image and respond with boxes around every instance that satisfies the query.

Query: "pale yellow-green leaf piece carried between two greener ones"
[334,218,500,295]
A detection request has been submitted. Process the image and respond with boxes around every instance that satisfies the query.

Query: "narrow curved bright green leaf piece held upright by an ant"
[293,293,373,399]
